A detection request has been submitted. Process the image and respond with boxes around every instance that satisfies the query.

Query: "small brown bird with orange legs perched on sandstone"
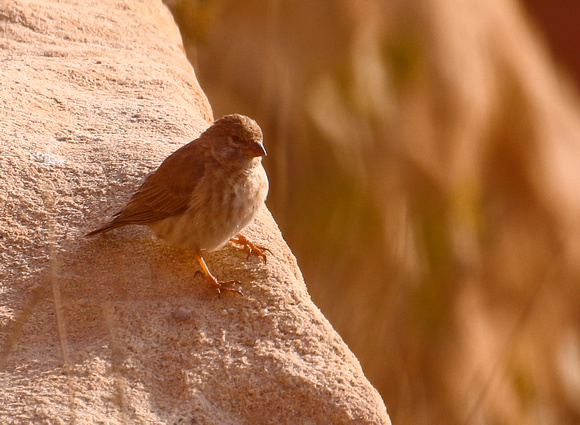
[87,114,268,294]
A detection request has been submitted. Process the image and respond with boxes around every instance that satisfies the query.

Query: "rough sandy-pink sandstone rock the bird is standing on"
[0,0,390,424]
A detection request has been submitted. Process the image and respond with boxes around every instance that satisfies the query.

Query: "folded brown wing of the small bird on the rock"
[106,140,211,229]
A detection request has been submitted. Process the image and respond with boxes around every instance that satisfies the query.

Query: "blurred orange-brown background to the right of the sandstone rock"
[162,0,580,425]
